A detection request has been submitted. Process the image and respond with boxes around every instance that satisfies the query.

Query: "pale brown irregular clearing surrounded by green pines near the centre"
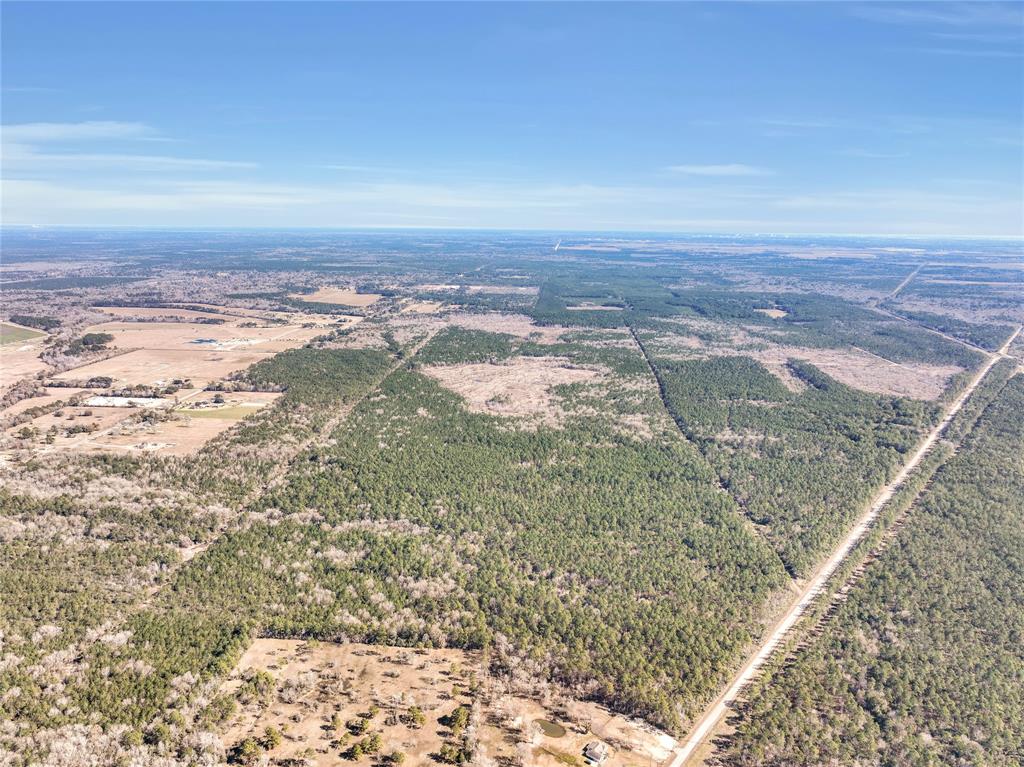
[423,356,602,424]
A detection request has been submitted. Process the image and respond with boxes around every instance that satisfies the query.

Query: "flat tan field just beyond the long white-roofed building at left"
[50,348,272,388]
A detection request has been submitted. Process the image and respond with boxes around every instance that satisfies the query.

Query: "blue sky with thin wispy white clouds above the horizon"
[2,2,1024,236]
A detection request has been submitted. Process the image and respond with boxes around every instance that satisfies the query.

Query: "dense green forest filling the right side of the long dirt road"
[724,375,1024,767]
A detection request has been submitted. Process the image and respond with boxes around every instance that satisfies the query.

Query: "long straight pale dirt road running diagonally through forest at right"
[667,328,1021,767]
